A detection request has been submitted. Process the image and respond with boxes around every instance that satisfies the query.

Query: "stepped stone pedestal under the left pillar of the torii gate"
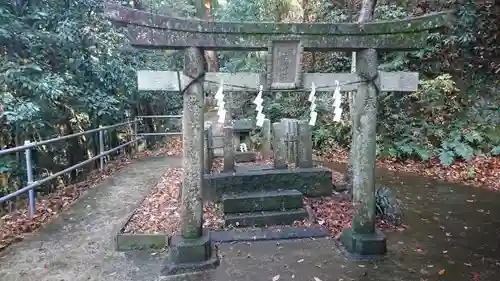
[161,233,220,275]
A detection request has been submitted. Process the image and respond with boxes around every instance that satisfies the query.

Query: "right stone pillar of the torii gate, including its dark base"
[341,49,387,255]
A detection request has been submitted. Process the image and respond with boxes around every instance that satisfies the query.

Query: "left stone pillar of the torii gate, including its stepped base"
[162,48,219,275]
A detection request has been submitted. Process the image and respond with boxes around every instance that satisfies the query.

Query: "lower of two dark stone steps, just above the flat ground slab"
[224,208,307,227]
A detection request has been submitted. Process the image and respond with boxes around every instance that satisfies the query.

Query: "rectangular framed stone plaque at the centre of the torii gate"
[268,40,303,90]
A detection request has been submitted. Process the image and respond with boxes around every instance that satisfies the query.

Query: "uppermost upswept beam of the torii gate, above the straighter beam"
[105,4,453,36]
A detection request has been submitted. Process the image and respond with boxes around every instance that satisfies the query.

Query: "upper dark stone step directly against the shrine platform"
[222,189,304,214]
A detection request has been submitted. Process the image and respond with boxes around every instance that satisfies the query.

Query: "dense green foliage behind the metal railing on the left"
[0,0,184,201]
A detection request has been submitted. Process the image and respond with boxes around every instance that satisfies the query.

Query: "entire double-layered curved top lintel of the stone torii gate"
[104,3,453,51]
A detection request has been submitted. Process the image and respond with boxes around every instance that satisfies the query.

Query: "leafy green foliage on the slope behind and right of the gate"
[226,1,500,166]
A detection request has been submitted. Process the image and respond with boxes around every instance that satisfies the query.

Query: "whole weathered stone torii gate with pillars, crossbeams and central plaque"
[105,4,451,274]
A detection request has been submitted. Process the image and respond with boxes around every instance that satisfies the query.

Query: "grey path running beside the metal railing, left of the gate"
[0,157,182,281]
